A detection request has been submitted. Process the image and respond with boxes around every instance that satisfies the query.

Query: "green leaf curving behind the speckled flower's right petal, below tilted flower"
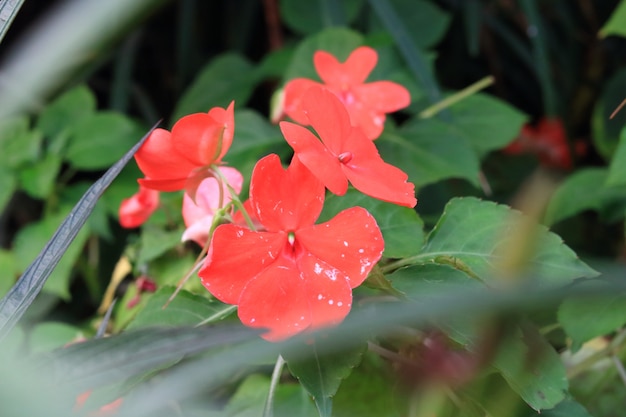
[318,189,424,258]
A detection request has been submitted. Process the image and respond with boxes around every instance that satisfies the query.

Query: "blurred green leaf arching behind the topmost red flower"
[284,28,363,81]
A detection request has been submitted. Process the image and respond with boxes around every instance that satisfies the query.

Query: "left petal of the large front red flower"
[198,224,287,304]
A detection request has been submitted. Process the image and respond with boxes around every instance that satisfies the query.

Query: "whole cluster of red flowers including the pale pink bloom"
[120,47,417,341]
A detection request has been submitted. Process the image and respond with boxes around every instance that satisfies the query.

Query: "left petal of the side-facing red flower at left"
[135,129,196,191]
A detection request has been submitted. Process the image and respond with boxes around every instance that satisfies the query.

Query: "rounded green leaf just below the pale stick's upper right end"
[450,93,526,157]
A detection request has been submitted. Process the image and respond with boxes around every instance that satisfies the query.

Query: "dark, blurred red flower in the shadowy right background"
[504,118,586,170]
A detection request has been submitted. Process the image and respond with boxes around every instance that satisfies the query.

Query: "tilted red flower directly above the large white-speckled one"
[280,87,417,207]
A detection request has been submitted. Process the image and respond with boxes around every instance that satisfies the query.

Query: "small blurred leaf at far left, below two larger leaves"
[19,153,61,200]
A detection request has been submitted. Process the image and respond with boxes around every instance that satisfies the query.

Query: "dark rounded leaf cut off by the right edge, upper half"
[591,68,626,161]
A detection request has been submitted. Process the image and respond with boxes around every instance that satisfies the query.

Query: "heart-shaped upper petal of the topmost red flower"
[313,46,378,86]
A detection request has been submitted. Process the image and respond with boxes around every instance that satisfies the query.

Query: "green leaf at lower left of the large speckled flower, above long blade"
[128,287,232,329]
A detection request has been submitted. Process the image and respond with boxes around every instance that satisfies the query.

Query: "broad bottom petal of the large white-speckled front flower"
[234,254,352,341]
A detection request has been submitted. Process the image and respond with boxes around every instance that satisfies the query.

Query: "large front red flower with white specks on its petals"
[198,155,384,341]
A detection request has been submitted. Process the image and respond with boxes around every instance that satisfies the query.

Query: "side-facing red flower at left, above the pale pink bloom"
[135,102,235,191]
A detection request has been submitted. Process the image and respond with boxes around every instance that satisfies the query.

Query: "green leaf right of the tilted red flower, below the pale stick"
[376,119,480,189]
